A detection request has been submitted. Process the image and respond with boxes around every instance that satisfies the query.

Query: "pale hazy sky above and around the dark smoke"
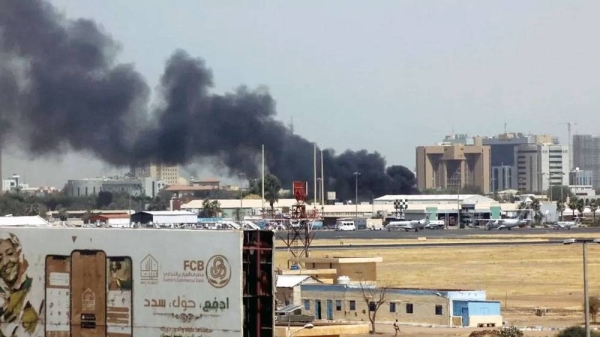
[3,0,600,187]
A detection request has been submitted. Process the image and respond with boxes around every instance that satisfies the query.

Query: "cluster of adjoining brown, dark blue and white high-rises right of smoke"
[416,133,571,194]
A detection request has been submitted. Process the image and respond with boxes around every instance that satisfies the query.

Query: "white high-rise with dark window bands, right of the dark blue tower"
[515,144,569,192]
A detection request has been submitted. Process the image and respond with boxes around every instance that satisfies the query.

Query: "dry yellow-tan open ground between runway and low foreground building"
[275,237,600,337]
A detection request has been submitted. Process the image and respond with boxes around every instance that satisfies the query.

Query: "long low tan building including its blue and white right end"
[300,284,502,327]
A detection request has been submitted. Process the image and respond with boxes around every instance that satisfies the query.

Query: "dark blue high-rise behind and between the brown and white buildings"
[474,132,558,191]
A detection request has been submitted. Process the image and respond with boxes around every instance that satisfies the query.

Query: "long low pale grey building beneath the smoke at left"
[65,177,165,198]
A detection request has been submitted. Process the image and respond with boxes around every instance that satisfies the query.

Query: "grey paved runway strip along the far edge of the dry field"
[276,227,600,240]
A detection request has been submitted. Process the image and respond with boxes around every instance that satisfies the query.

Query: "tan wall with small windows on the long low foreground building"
[302,286,450,325]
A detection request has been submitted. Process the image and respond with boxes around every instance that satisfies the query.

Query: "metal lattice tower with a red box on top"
[277,181,321,267]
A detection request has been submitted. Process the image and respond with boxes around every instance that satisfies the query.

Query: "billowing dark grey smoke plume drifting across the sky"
[0,0,415,199]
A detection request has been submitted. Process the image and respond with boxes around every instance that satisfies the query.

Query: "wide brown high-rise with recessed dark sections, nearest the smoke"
[416,142,490,193]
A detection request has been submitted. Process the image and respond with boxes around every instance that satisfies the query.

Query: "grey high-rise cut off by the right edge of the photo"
[573,135,600,188]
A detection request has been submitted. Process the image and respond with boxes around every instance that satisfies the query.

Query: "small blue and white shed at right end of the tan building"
[452,300,502,327]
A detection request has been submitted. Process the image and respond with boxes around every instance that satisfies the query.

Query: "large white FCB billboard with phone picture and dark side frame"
[0,227,275,337]
